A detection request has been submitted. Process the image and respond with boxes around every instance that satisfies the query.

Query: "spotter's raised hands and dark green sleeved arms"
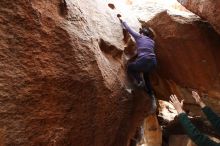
[170,91,220,146]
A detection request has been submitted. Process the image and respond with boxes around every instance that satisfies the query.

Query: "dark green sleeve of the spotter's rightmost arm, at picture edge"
[202,106,220,133]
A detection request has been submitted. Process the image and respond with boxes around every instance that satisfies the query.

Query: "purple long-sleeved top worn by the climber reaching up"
[122,21,155,59]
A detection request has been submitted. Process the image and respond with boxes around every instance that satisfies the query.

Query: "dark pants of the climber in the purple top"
[127,56,157,96]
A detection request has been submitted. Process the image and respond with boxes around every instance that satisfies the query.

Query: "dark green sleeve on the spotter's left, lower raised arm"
[179,113,220,146]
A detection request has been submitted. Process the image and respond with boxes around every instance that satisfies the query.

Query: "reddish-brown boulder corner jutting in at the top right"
[177,0,220,33]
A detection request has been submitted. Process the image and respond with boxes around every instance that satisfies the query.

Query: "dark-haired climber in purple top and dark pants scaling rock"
[117,14,157,98]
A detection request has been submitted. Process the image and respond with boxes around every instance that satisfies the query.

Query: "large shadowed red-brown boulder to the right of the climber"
[148,12,220,113]
